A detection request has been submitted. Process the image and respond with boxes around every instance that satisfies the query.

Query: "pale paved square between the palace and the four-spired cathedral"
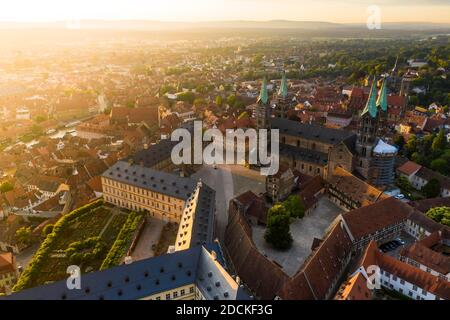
[192,165,265,243]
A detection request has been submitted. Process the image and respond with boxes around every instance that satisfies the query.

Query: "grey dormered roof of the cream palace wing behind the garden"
[102,161,197,200]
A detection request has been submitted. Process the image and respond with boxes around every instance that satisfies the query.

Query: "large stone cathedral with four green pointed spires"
[254,77,397,186]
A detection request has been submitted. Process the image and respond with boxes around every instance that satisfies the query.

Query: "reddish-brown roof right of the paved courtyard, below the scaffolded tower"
[342,198,414,239]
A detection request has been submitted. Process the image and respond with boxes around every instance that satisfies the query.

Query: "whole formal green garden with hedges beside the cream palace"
[14,200,144,291]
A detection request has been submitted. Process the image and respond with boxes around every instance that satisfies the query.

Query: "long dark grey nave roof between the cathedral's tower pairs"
[270,118,354,145]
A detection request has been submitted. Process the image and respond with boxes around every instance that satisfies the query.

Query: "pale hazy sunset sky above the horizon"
[0,0,450,23]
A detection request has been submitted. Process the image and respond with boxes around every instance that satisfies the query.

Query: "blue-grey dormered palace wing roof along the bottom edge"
[4,244,249,300]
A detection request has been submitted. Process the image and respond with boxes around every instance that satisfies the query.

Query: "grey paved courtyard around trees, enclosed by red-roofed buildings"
[252,196,343,276]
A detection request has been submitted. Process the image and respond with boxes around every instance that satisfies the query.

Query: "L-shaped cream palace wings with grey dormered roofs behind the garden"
[102,161,215,250]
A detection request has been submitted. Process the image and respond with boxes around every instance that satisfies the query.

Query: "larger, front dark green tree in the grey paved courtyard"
[264,204,293,250]
